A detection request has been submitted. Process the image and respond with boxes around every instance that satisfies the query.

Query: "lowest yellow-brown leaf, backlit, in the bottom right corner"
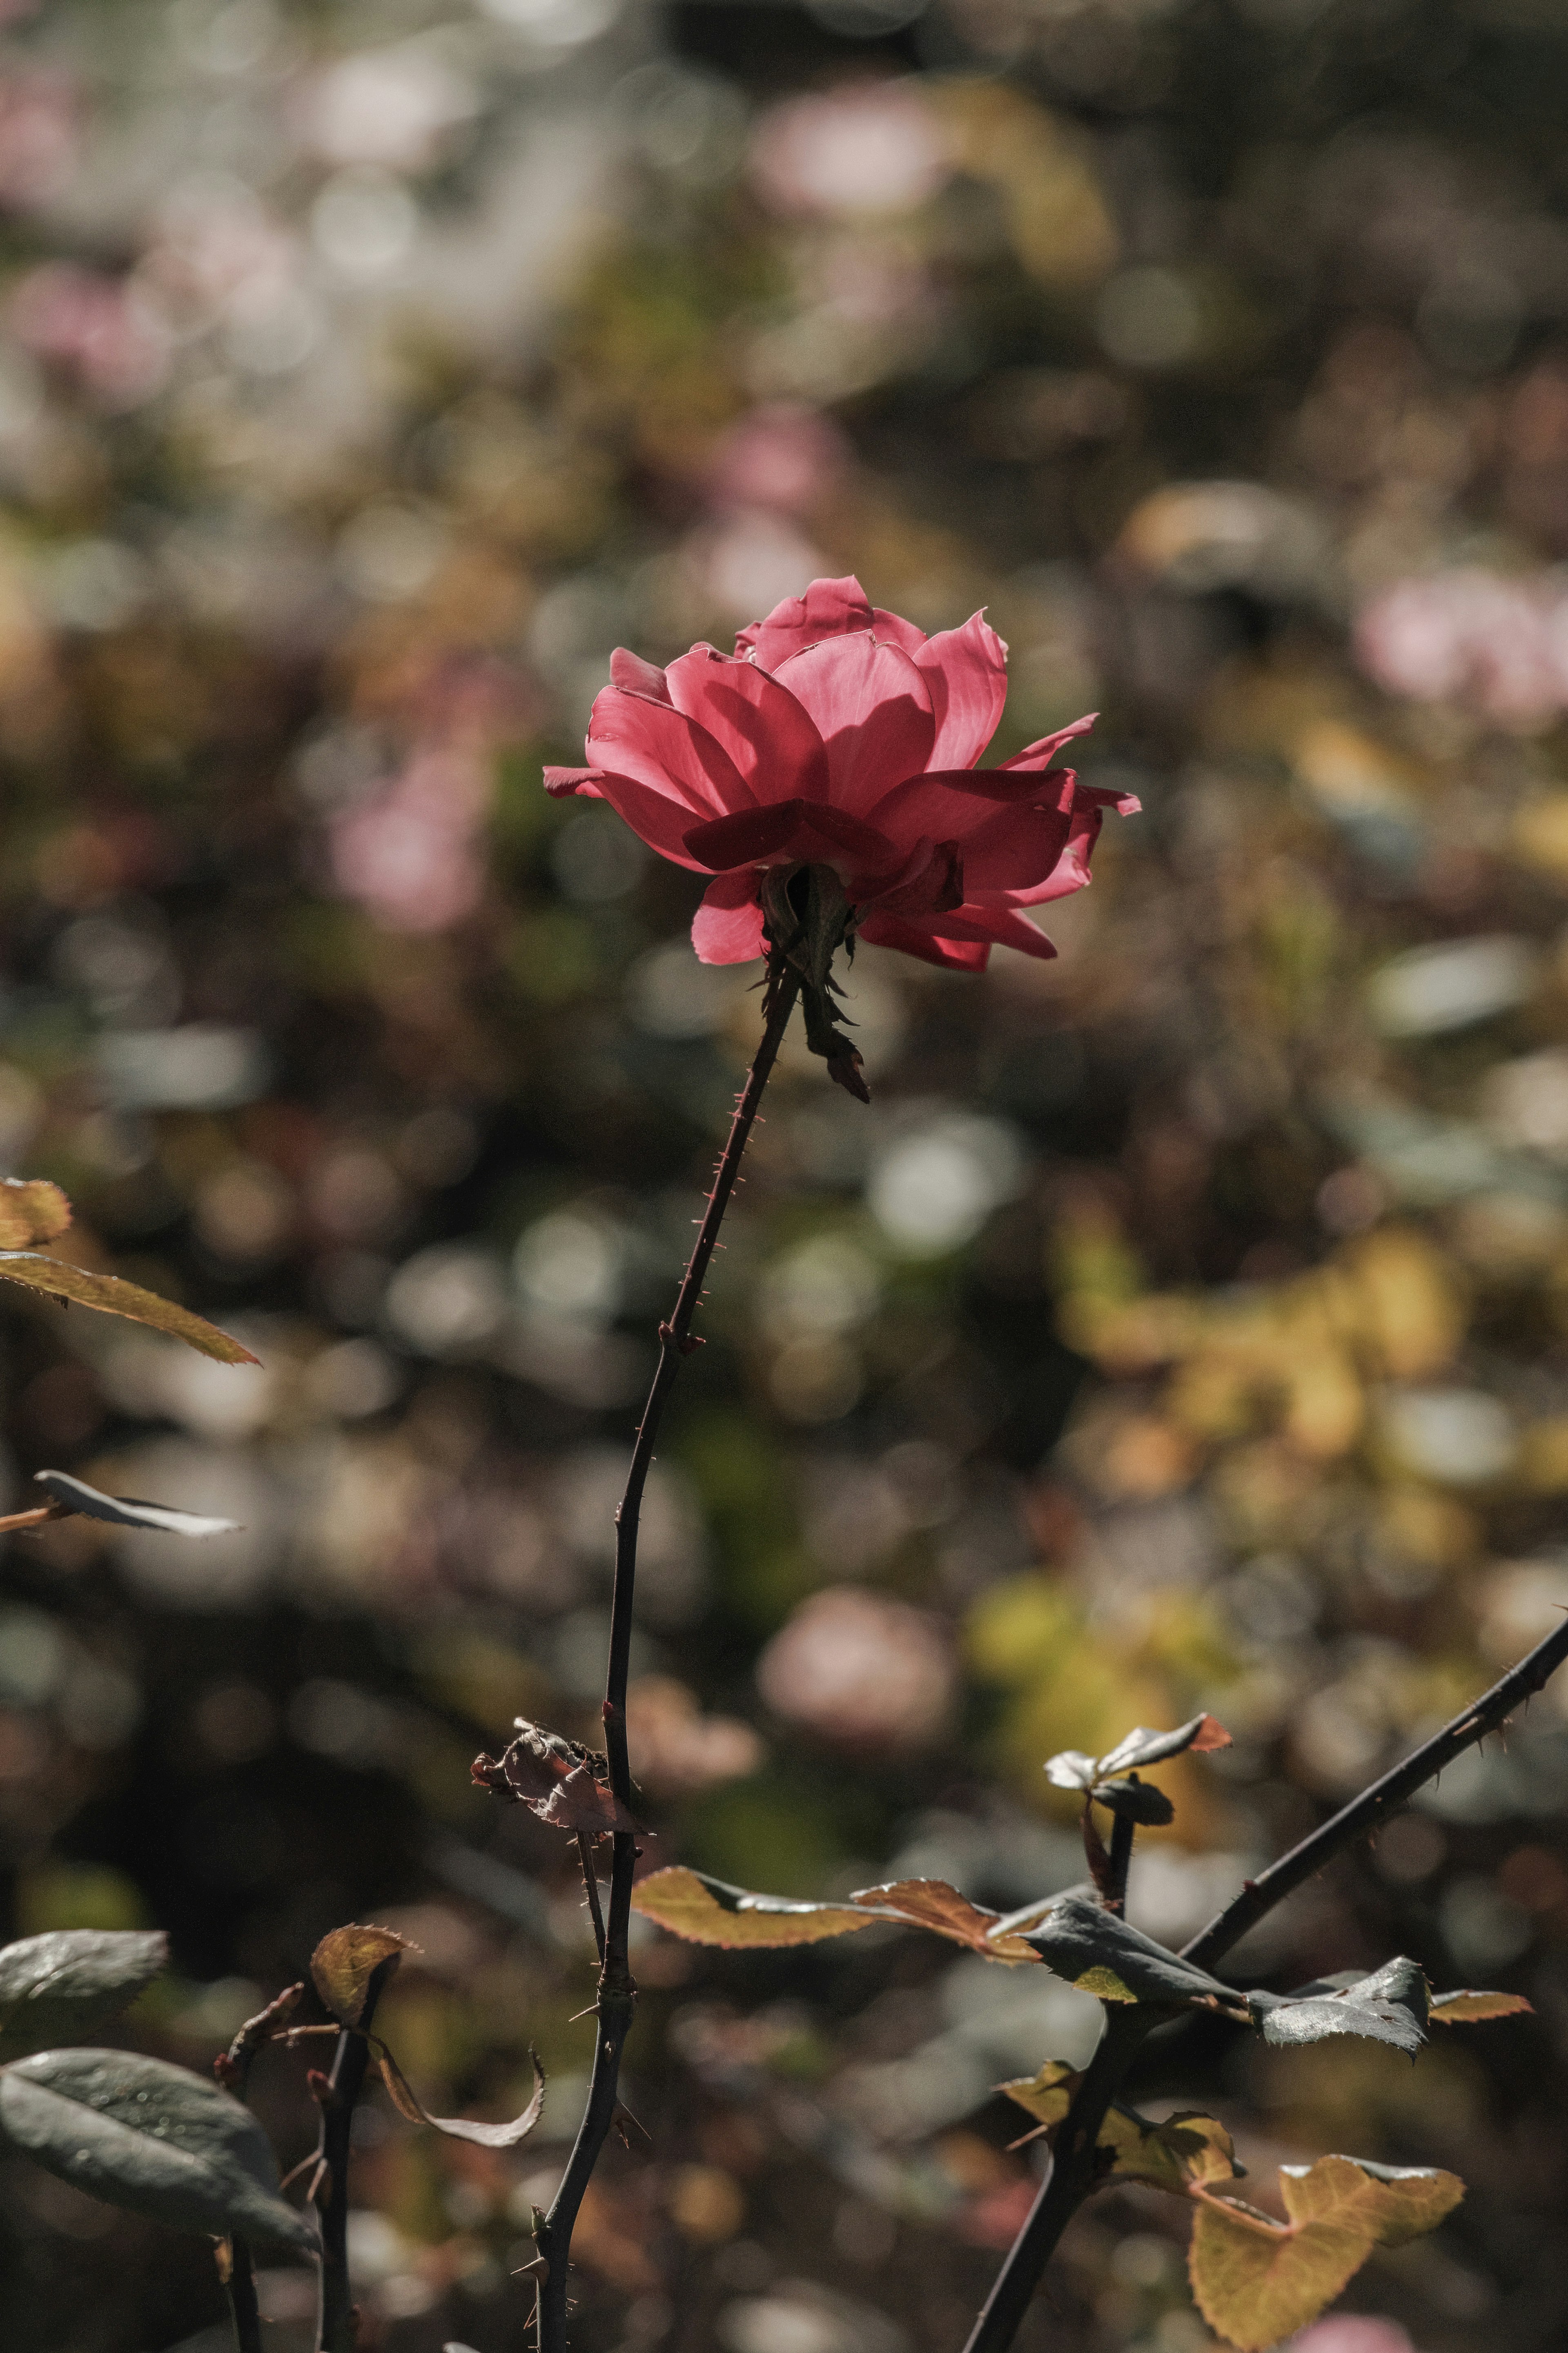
[1187,2158,1465,2353]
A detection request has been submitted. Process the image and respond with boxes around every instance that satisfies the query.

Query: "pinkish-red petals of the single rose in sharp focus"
[546,579,1138,972]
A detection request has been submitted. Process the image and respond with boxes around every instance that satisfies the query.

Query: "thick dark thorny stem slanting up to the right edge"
[964,1619,1568,2353]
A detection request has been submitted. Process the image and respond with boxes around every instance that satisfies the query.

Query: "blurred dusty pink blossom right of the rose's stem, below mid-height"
[757,1586,954,1748]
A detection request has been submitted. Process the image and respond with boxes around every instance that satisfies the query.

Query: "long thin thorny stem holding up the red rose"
[541,958,799,2353]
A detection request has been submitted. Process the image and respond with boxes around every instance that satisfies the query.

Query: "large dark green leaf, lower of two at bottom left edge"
[0,2050,315,2250]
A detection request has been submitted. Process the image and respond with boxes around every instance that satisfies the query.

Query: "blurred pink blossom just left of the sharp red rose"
[329,746,489,932]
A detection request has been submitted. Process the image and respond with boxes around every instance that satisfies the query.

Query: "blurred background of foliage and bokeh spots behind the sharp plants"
[0,0,1568,2353]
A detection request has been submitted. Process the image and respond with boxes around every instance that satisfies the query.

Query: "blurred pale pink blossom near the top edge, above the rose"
[752,83,947,214]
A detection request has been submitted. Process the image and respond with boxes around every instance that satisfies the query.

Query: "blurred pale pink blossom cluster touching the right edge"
[1356,565,1568,727]
